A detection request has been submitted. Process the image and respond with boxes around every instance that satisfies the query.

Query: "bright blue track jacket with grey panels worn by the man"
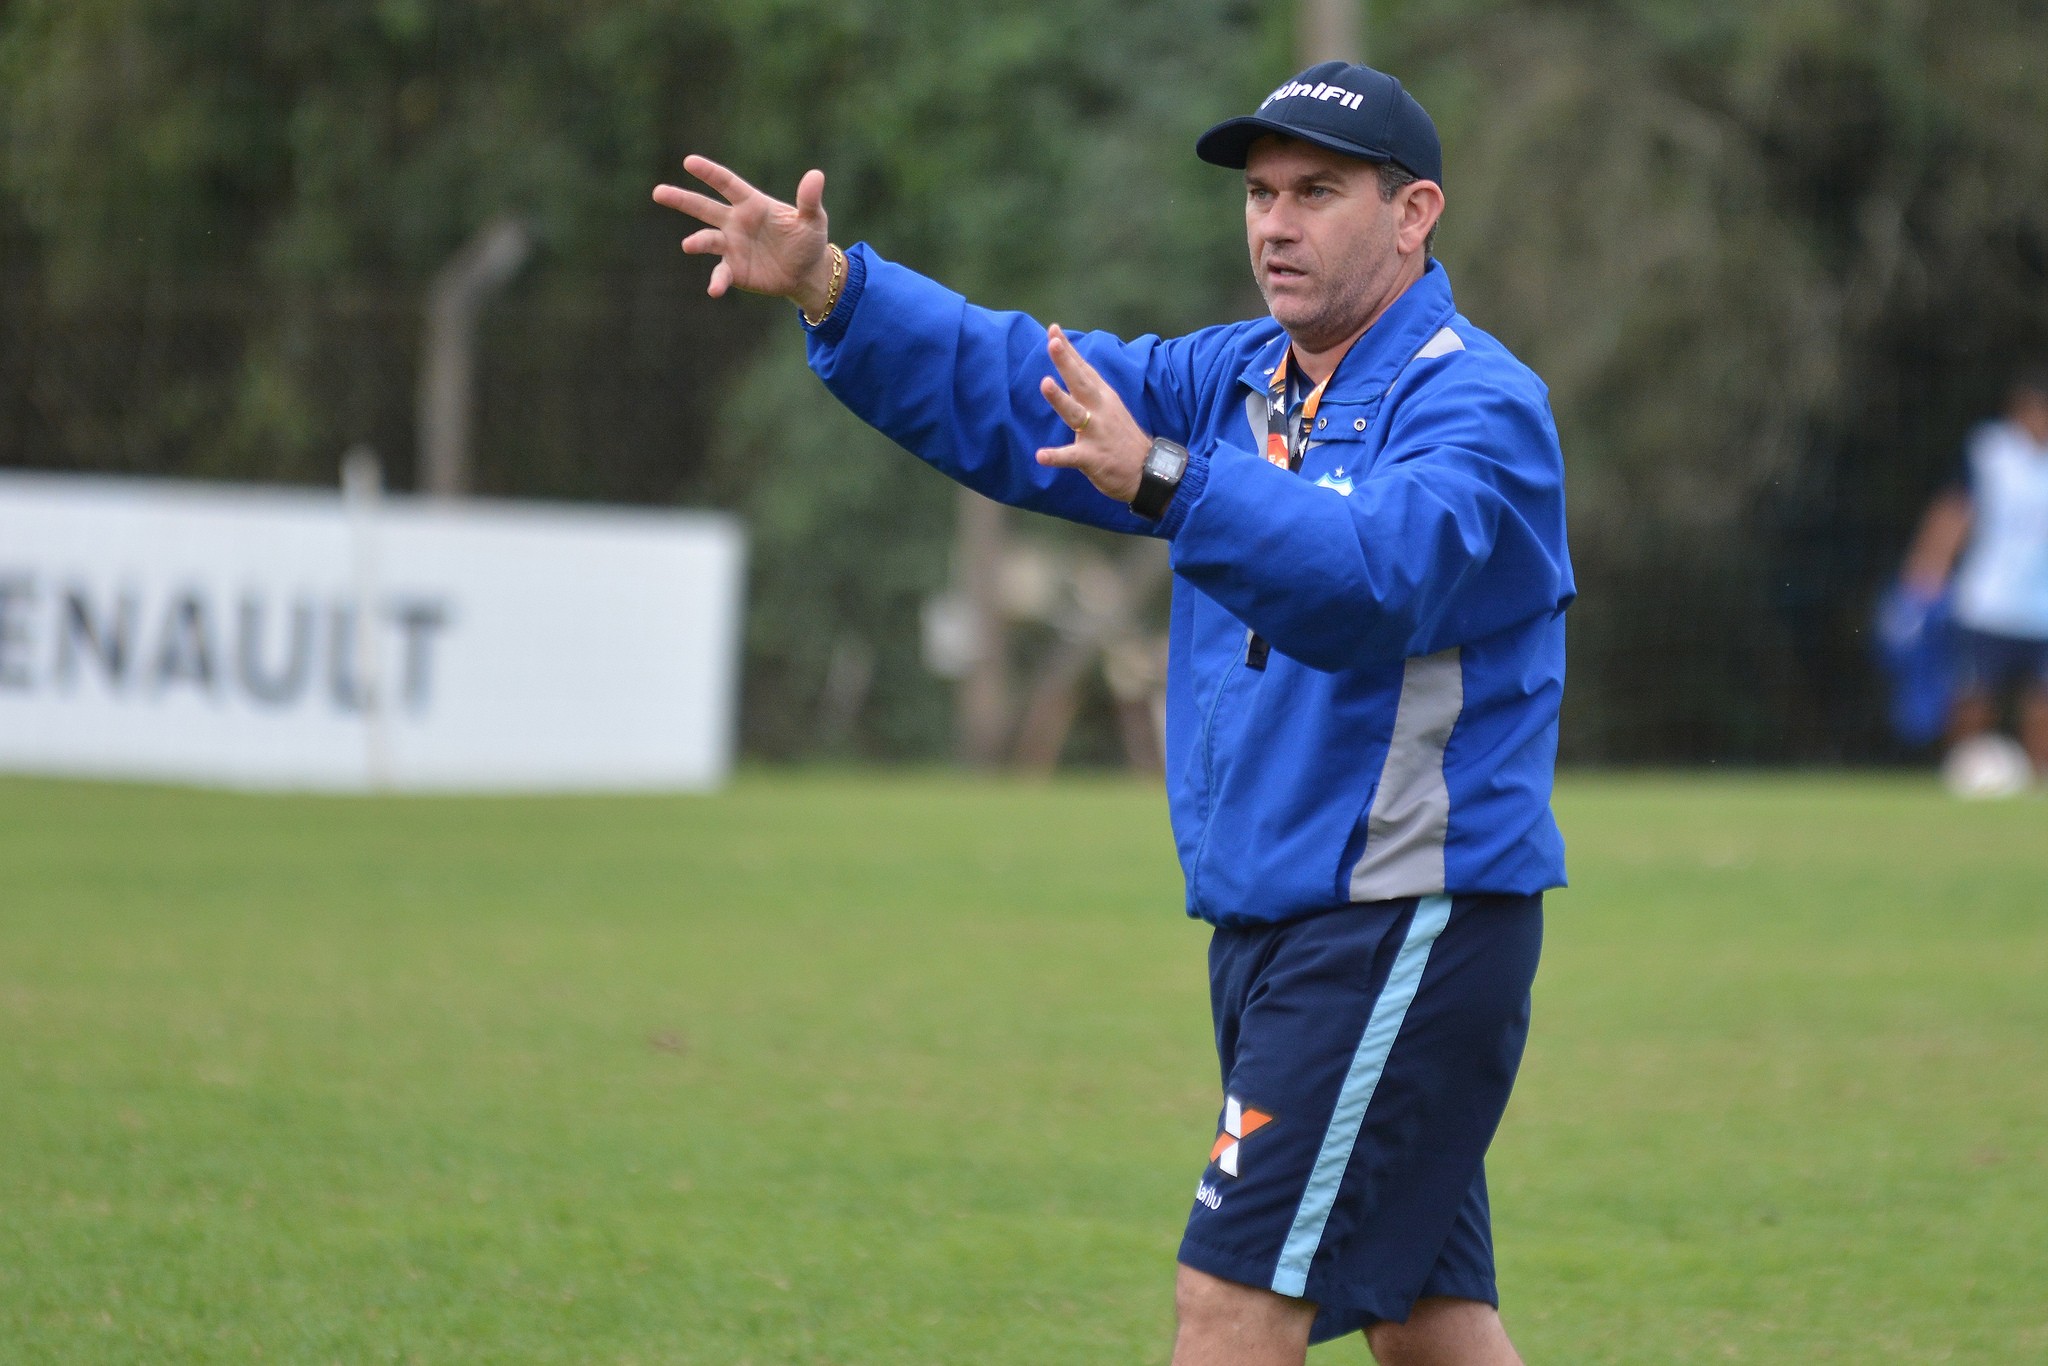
[809,246,1573,926]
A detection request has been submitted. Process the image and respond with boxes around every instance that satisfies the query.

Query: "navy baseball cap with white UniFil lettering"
[1194,61,1444,184]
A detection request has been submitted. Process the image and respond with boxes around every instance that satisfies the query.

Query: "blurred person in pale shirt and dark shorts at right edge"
[1905,367,2048,776]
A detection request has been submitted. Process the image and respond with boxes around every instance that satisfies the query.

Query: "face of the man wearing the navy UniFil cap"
[1245,137,1436,350]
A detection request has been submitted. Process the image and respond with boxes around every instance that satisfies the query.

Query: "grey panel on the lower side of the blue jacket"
[1352,647,1464,901]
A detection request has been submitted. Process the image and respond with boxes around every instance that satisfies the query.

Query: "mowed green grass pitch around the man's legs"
[0,776,2048,1366]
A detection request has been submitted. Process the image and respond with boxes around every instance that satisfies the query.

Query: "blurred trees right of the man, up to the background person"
[1376,0,2048,758]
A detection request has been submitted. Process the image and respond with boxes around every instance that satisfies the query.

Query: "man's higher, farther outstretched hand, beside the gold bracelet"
[653,156,831,317]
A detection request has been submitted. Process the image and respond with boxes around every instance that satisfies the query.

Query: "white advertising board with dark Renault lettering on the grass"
[0,473,743,791]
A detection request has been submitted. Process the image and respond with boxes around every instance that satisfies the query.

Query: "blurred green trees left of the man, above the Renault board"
[0,0,1286,770]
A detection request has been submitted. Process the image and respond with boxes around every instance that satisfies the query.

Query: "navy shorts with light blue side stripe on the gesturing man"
[1180,895,1542,1341]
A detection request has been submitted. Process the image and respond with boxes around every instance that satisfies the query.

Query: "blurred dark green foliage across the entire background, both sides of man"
[0,0,2048,762]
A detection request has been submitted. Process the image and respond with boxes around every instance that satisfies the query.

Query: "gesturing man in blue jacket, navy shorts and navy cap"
[655,61,1573,1366]
